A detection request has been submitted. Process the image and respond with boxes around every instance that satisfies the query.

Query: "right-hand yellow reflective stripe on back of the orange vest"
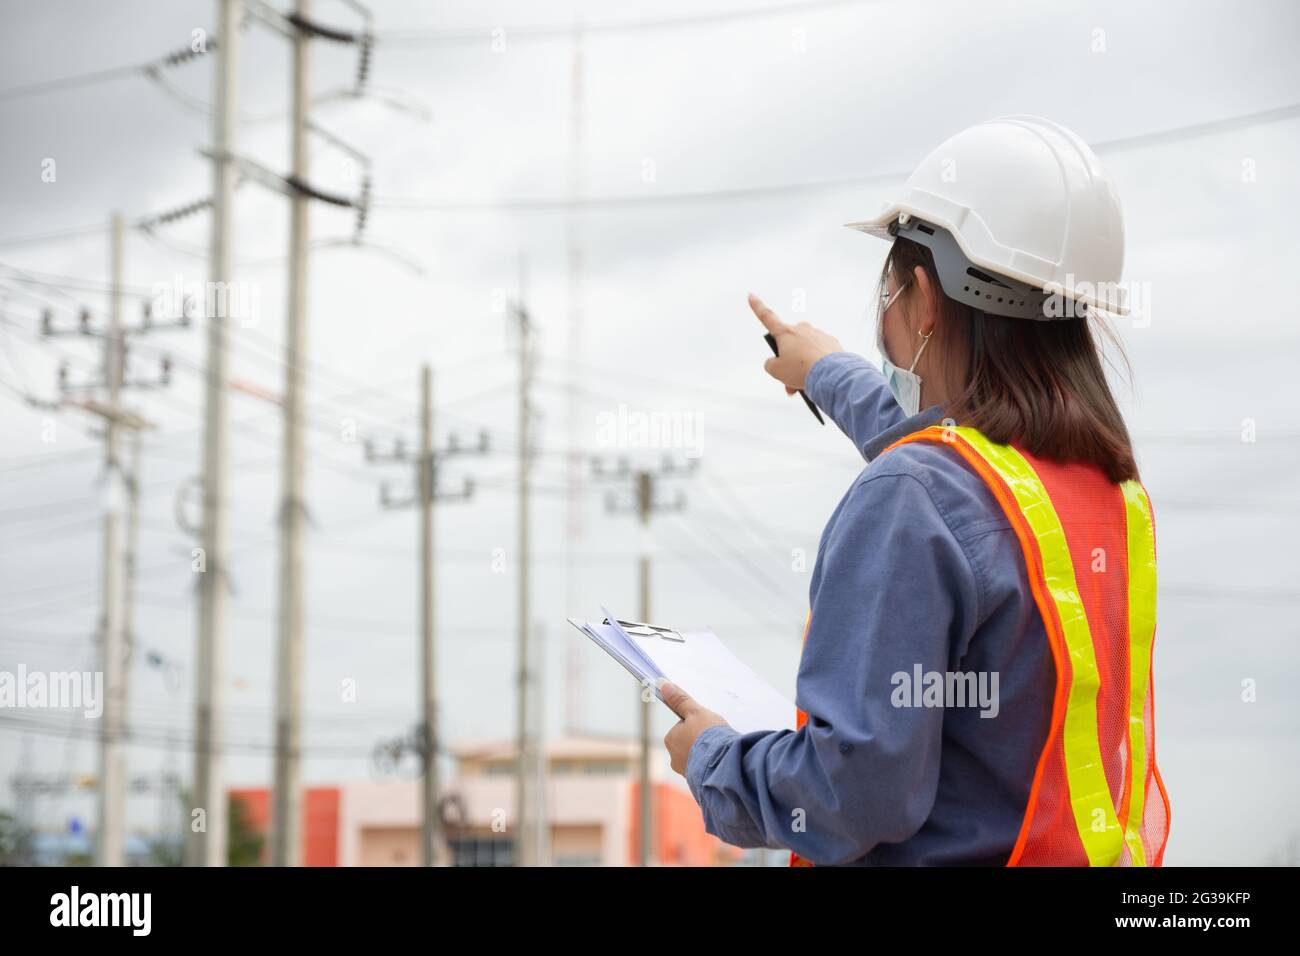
[1121,481,1156,866]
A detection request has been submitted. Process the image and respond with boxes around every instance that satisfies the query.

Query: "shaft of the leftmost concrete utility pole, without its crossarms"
[96,213,127,866]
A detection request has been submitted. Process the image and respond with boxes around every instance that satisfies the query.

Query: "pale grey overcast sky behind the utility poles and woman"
[0,0,1300,864]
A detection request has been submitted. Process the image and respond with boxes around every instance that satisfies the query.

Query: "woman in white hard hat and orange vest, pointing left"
[663,116,1170,866]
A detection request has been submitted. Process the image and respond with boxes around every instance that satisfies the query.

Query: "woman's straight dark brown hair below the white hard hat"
[880,238,1138,483]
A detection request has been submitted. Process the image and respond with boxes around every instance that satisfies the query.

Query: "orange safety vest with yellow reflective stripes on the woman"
[790,425,1170,866]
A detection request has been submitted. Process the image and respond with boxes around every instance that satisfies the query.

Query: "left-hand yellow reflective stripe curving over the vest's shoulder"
[950,427,1123,866]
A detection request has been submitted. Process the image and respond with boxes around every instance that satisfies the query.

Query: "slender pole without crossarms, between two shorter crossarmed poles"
[515,261,538,866]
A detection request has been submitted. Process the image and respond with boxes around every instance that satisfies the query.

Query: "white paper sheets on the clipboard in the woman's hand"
[568,607,794,734]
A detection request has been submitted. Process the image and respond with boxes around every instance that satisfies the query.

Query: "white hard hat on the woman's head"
[849,116,1128,319]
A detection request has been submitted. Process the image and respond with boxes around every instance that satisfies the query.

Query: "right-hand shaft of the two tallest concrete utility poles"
[270,0,312,866]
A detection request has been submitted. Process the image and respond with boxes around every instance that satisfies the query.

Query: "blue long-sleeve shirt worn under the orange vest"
[686,352,1056,865]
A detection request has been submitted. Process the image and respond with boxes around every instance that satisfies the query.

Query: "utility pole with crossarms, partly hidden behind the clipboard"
[592,458,698,866]
